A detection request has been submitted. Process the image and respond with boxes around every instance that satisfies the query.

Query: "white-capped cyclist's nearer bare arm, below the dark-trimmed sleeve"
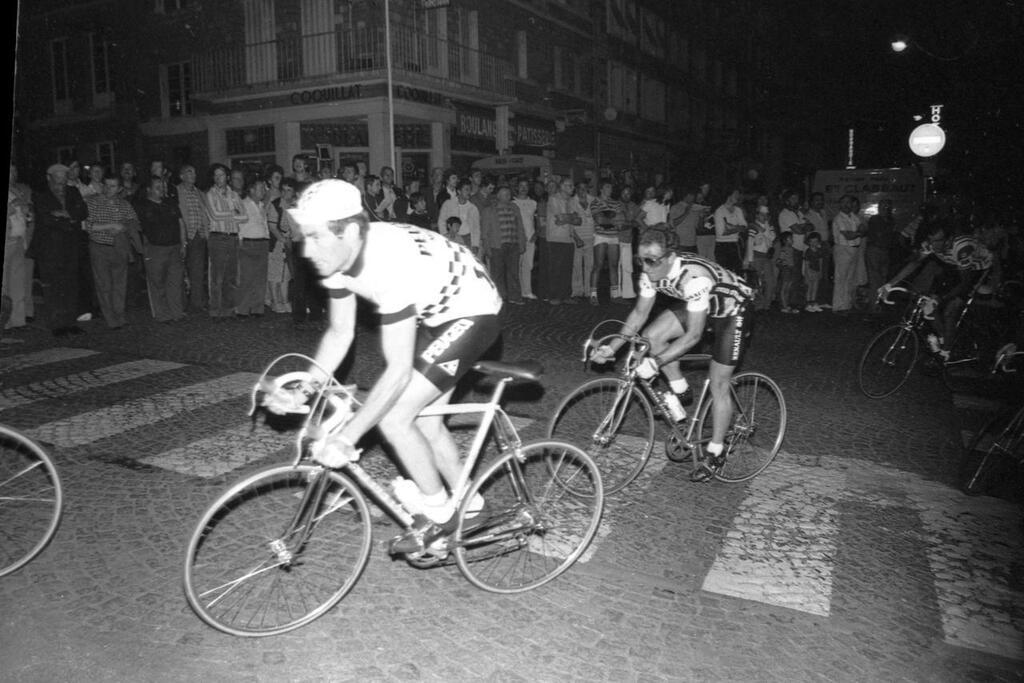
[333,315,416,443]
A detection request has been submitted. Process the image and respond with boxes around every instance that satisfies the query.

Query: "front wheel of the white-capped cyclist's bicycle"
[184,465,371,636]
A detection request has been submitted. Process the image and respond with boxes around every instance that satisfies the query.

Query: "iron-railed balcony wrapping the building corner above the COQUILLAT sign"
[194,26,515,98]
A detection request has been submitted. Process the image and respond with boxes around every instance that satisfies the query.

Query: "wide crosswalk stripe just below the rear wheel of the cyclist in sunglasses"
[702,462,846,616]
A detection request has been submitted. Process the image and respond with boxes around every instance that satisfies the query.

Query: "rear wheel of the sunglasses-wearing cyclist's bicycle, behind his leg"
[696,372,786,483]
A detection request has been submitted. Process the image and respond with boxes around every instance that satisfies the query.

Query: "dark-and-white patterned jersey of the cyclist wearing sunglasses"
[639,252,754,317]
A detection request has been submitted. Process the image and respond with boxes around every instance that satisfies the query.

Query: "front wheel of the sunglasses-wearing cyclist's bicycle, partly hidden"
[548,377,654,495]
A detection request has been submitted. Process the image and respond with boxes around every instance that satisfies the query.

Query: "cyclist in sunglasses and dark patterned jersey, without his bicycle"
[591,229,754,481]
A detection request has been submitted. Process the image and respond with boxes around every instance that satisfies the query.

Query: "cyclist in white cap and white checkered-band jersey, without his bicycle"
[276,179,502,552]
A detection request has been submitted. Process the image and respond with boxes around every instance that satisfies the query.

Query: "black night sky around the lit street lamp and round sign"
[772,0,1024,195]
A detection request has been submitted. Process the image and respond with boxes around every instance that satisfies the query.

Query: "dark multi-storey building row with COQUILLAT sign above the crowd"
[14,0,778,188]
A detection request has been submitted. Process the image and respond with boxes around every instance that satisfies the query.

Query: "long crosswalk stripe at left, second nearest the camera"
[27,373,259,447]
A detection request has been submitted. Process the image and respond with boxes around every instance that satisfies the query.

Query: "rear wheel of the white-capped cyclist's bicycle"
[453,441,604,593]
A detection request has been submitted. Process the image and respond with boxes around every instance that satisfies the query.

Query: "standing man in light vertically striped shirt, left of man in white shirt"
[206,164,246,317]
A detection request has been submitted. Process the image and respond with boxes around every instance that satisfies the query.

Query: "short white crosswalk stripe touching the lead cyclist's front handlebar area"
[138,423,296,478]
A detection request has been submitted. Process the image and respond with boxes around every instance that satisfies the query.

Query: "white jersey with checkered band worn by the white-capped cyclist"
[324,222,502,327]
